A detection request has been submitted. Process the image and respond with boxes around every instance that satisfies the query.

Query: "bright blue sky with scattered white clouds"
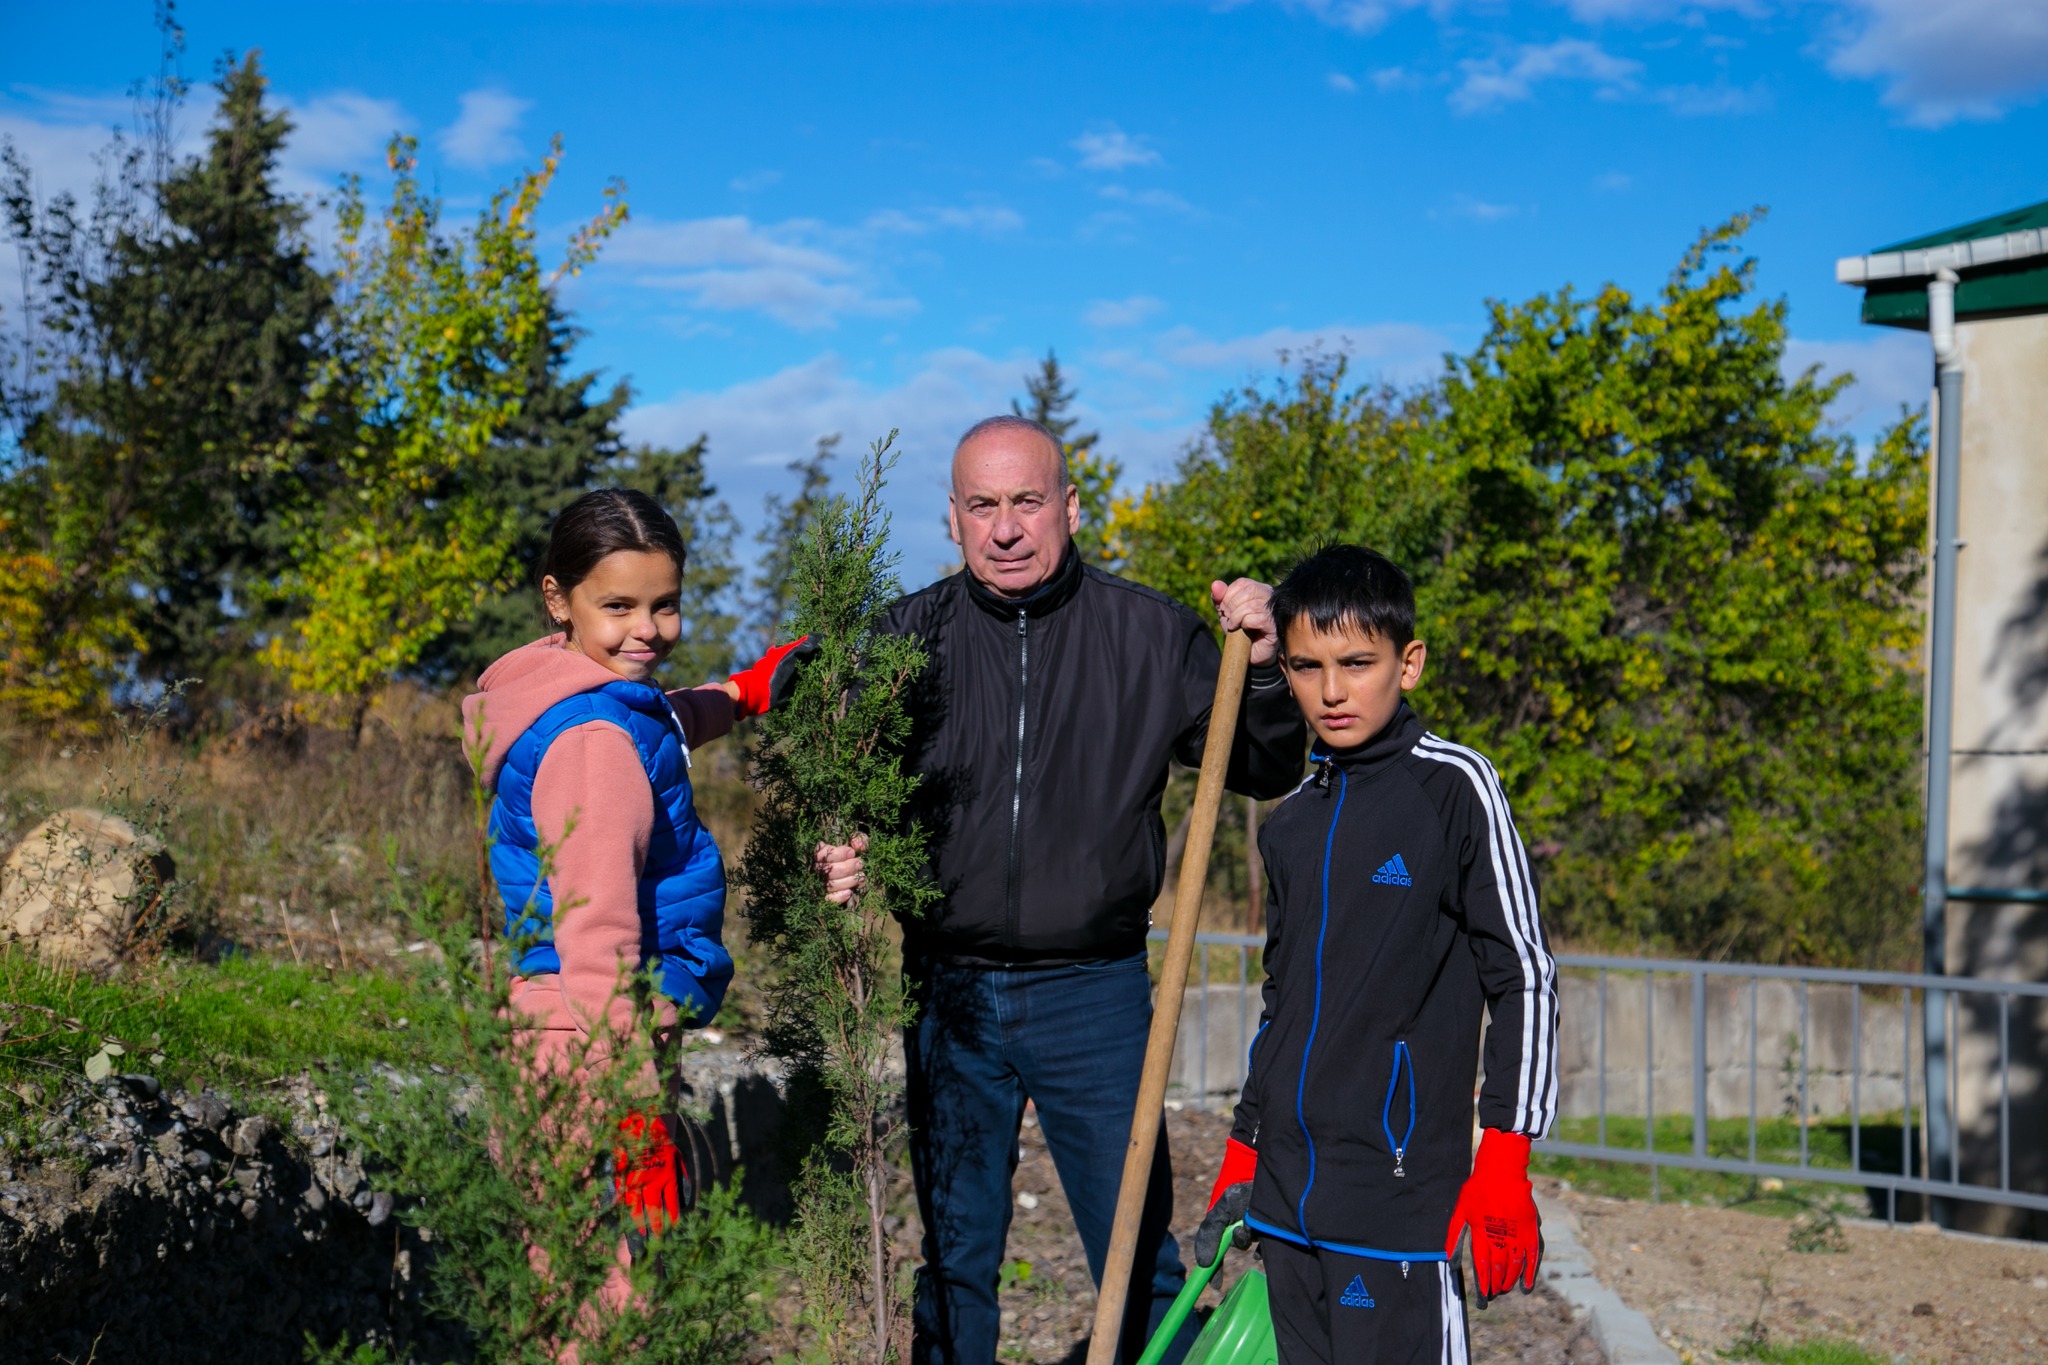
[0,0,2048,579]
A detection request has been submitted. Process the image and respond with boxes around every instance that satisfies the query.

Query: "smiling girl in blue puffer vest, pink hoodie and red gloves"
[463,489,815,1232]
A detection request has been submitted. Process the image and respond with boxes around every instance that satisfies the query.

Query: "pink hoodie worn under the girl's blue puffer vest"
[463,634,733,1031]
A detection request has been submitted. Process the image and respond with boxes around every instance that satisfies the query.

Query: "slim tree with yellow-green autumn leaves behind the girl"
[268,137,625,718]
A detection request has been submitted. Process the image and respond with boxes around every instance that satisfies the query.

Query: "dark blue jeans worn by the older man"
[903,954,1196,1365]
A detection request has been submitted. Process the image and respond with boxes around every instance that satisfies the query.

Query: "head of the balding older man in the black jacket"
[946,428,1081,598]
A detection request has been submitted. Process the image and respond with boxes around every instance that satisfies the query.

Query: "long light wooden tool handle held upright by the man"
[1087,630,1251,1365]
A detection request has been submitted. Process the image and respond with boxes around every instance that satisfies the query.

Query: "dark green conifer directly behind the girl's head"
[420,313,737,684]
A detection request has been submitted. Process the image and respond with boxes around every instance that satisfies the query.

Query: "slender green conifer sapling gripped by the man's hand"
[737,434,932,1365]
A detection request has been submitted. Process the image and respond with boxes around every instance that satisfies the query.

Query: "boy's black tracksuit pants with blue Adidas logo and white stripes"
[1260,1236,1470,1365]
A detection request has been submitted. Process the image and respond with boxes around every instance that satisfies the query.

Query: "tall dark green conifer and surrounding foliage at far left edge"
[0,34,330,712]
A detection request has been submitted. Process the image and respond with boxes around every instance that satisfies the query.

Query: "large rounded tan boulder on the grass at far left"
[0,806,176,972]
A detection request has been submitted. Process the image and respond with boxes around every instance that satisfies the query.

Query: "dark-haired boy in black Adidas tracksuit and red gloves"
[1196,544,1556,1365]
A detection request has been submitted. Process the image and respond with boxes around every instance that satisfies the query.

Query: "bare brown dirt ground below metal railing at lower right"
[1542,1181,2048,1363]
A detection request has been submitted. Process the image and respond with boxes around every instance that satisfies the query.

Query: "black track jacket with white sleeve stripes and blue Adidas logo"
[1231,702,1556,1261]
